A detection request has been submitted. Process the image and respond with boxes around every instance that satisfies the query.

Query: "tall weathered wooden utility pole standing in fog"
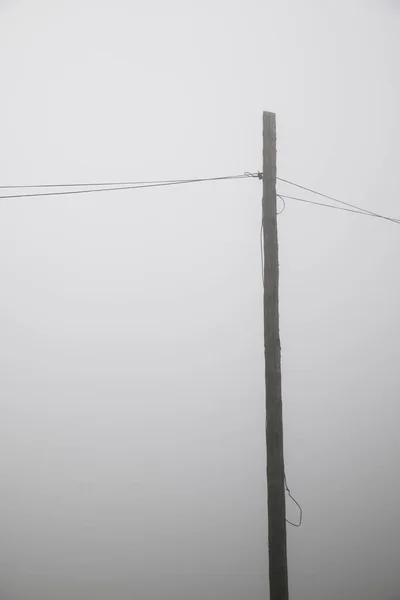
[262,112,289,600]
